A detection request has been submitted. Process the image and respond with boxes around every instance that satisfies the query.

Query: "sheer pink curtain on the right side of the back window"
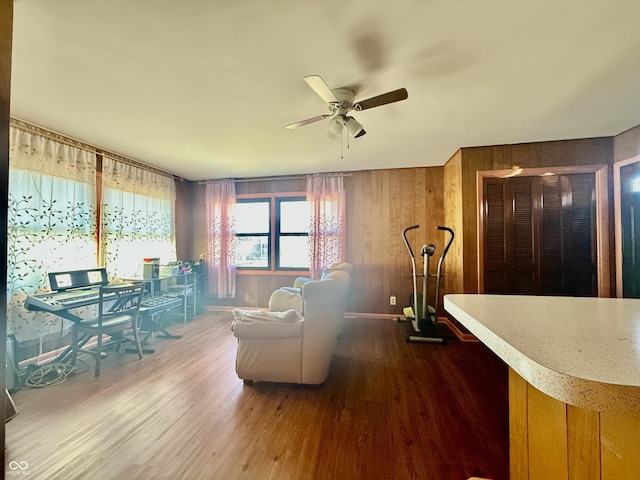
[307,174,346,278]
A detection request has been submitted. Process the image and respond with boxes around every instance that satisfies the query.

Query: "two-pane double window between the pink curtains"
[236,196,309,271]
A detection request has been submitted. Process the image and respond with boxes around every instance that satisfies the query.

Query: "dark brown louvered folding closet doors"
[483,174,597,296]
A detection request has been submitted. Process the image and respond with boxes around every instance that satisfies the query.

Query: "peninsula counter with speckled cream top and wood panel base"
[444,295,640,480]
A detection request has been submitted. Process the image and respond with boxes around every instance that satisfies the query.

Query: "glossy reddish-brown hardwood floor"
[5,313,508,480]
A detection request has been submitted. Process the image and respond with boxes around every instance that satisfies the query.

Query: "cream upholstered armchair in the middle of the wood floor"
[233,270,350,385]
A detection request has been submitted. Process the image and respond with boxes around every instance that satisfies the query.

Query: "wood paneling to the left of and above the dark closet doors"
[445,137,613,293]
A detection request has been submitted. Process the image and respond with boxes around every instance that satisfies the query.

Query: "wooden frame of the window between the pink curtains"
[236,192,310,276]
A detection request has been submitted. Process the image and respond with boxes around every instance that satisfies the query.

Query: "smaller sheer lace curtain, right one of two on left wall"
[100,157,176,279]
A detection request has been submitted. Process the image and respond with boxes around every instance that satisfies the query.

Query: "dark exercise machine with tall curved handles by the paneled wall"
[402,225,454,344]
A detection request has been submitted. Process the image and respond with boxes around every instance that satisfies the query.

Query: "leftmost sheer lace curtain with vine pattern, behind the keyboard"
[7,125,97,344]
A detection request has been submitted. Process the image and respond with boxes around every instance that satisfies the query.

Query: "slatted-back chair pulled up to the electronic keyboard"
[71,282,144,377]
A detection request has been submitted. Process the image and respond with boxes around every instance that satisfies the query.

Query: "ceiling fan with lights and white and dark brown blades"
[287,75,408,140]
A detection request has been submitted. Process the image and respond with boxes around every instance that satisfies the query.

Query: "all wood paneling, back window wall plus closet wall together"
[177,137,620,316]
